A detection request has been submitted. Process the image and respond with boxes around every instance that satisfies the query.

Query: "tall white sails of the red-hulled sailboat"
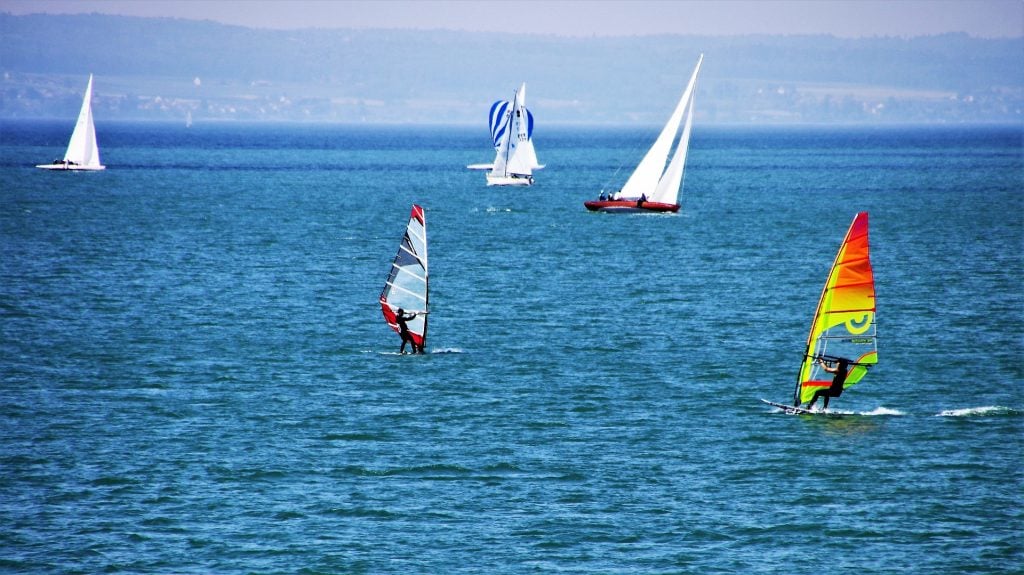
[617,54,703,204]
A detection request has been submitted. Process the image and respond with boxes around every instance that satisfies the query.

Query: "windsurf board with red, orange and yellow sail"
[762,212,879,413]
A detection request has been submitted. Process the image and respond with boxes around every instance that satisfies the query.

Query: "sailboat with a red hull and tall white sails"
[584,54,703,213]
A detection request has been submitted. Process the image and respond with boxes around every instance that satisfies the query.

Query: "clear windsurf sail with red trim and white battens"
[380,204,430,353]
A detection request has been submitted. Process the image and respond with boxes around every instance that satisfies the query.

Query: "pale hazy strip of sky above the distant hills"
[0,0,1024,38]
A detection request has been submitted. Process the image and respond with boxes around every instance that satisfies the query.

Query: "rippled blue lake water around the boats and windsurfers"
[0,118,1024,574]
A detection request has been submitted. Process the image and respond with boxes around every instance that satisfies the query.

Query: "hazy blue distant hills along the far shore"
[0,13,1024,125]
